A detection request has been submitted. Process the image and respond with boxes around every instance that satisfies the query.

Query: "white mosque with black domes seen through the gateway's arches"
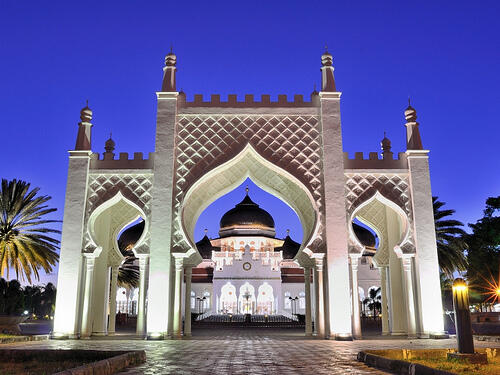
[117,188,380,316]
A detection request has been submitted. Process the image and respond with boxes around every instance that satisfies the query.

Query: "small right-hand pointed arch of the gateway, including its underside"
[348,190,410,266]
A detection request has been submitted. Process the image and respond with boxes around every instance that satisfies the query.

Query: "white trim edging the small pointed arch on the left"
[87,191,149,257]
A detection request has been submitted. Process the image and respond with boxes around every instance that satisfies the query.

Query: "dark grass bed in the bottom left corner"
[0,360,85,375]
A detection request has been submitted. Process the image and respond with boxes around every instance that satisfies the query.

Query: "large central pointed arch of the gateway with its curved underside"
[182,144,319,262]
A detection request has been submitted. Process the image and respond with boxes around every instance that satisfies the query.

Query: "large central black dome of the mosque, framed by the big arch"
[220,193,274,230]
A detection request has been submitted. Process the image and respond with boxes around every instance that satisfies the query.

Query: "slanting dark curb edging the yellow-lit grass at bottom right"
[357,352,456,375]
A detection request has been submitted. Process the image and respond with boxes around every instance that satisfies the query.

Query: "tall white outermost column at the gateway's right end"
[406,150,444,334]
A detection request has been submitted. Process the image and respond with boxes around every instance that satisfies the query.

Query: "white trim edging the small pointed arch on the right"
[348,190,410,256]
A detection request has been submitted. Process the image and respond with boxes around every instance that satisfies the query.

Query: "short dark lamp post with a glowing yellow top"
[448,278,488,363]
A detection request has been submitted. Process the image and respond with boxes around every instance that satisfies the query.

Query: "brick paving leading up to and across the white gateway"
[0,329,500,375]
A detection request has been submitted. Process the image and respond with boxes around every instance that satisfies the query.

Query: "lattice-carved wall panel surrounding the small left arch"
[83,172,153,253]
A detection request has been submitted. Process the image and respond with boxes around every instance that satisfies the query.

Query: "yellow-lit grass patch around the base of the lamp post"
[366,348,500,375]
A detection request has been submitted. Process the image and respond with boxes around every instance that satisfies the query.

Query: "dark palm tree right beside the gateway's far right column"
[432,197,467,278]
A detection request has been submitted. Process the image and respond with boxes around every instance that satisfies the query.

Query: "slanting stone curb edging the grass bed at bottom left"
[55,350,146,375]
